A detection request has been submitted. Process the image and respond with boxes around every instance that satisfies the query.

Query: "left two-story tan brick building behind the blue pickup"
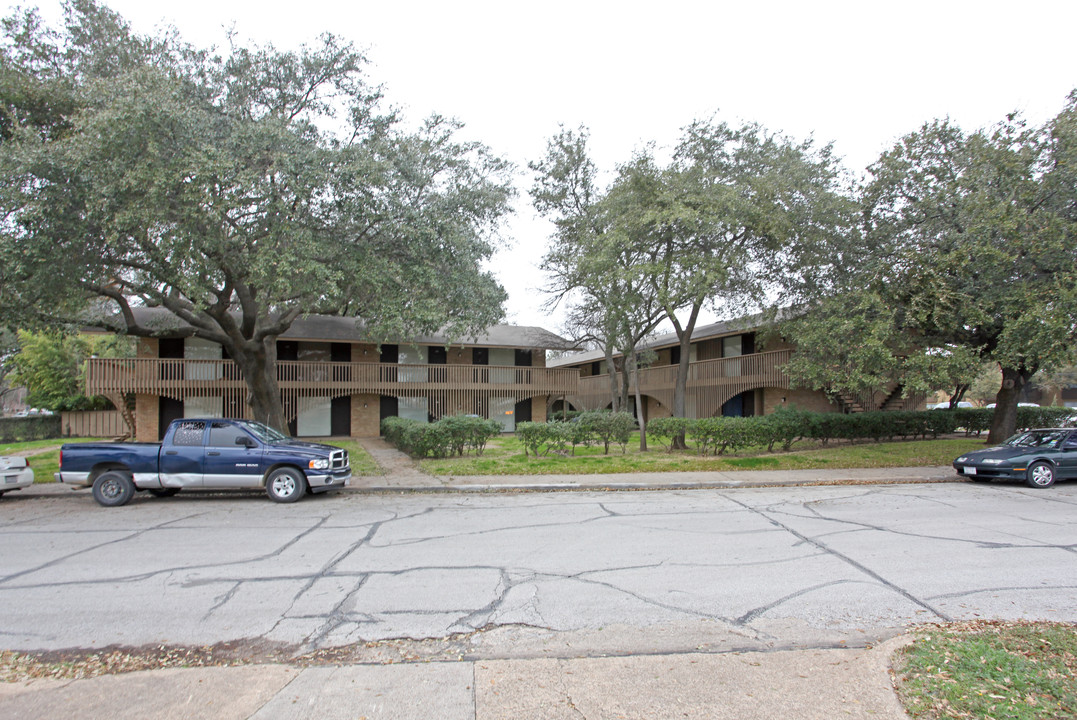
[86,310,579,440]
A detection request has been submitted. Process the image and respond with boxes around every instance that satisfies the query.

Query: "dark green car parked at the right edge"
[953,427,1077,488]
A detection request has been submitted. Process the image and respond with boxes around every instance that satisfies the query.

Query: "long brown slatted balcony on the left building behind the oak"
[86,357,578,399]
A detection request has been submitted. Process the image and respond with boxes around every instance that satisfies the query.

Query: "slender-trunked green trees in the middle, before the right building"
[531,119,854,417]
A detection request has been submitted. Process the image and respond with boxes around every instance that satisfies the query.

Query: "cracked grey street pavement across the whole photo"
[0,483,1077,658]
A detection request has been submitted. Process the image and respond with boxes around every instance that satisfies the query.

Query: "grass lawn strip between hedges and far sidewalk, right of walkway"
[420,436,983,475]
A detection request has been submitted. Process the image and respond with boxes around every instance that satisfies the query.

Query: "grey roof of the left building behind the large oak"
[95,308,578,350]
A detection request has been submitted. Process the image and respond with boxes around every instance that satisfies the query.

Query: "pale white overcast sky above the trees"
[8,0,1077,331]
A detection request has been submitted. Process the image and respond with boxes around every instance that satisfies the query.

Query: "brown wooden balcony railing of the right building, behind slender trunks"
[569,350,789,418]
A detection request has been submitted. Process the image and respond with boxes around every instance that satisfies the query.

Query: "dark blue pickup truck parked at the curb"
[56,418,351,507]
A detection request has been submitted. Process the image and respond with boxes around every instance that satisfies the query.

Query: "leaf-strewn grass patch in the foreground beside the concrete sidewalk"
[894,622,1077,720]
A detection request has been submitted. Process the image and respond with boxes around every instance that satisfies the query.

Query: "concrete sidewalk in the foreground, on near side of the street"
[0,637,908,720]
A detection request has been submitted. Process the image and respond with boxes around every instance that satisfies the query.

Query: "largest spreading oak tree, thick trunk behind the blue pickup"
[0,0,512,427]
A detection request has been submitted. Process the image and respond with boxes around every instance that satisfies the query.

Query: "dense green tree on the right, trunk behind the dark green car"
[783,91,1077,440]
